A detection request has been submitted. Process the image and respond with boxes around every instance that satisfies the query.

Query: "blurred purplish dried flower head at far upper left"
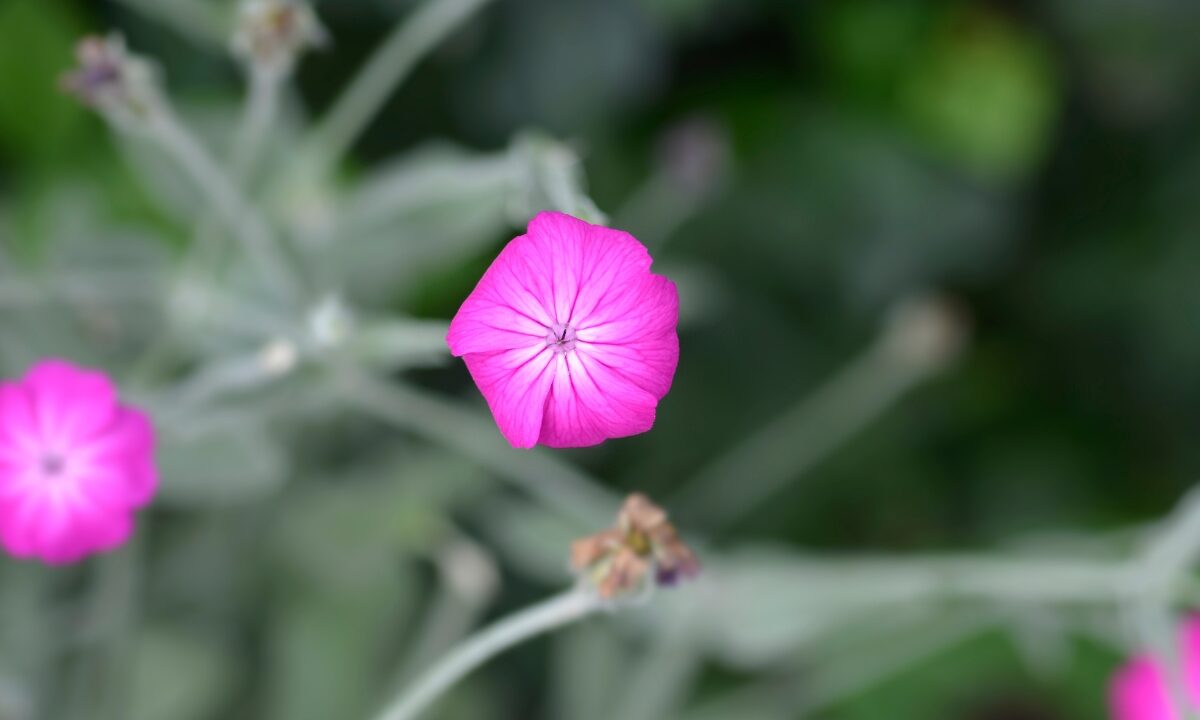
[61,35,163,130]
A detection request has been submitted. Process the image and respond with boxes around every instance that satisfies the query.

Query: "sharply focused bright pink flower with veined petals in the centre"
[446,212,679,448]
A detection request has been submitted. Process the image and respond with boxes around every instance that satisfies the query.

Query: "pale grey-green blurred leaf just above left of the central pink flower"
[314,134,605,302]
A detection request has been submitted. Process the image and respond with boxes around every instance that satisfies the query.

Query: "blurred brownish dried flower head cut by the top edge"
[232,0,328,73]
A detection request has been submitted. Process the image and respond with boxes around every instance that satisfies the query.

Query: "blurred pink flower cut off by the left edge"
[0,360,157,564]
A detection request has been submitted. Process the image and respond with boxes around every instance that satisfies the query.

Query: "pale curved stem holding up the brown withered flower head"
[377,588,602,720]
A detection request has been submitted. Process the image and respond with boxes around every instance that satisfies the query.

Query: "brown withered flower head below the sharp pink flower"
[571,493,700,600]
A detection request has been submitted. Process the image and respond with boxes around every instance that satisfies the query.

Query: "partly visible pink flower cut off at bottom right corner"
[1109,617,1200,720]
